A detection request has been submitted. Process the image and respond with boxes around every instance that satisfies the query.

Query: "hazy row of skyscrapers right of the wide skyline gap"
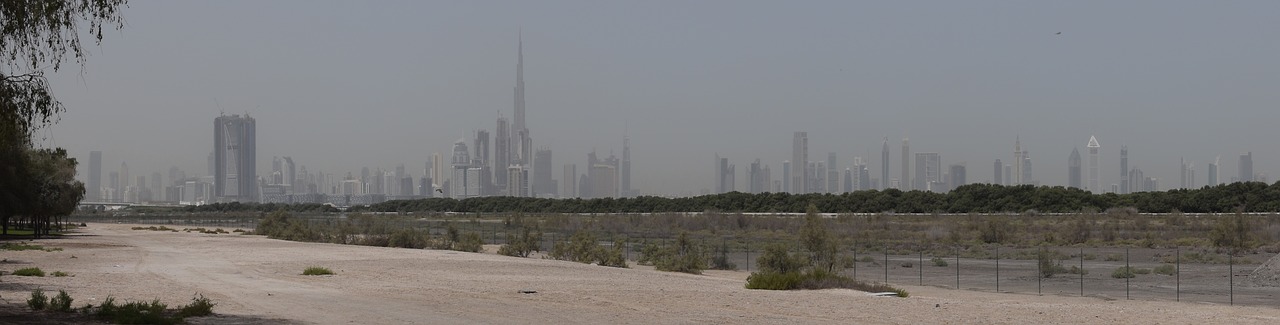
[707,132,1267,193]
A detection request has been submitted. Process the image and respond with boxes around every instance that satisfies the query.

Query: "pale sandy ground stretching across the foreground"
[0,224,1280,324]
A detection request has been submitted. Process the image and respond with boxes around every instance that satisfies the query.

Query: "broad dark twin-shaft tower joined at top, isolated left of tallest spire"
[213,114,257,202]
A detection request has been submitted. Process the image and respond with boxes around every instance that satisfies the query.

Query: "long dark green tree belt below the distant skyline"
[351,182,1280,214]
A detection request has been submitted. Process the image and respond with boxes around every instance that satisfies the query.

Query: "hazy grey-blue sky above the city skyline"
[42,1,1280,194]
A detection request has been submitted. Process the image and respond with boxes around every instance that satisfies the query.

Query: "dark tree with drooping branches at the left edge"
[0,0,127,232]
